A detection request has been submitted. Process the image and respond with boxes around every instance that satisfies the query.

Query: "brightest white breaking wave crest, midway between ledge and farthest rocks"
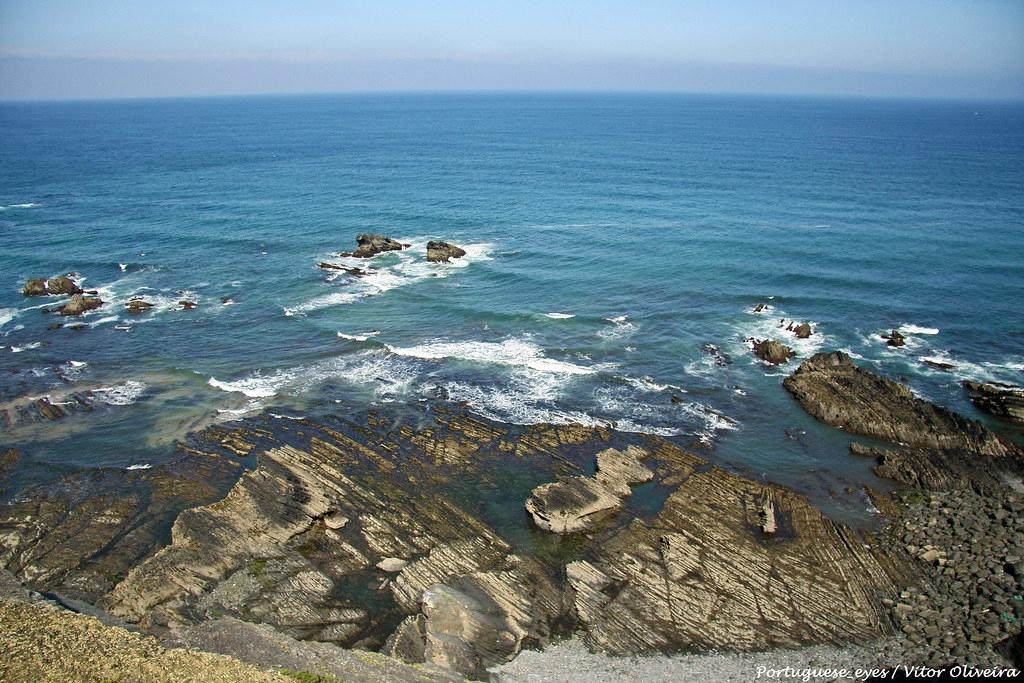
[387,338,596,375]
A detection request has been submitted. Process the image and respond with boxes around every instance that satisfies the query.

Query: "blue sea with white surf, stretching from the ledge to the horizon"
[0,94,1024,520]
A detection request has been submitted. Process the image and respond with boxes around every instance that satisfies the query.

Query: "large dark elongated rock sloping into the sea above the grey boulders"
[783,352,1015,457]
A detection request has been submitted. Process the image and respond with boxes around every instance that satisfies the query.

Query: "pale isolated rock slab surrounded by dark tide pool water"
[526,446,654,533]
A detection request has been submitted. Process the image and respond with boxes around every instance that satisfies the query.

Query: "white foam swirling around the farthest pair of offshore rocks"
[284,238,494,316]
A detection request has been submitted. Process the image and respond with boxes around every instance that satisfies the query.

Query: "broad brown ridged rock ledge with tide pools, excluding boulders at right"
[0,407,909,678]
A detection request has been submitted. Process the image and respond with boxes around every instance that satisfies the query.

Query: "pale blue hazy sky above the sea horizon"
[0,0,1024,100]
